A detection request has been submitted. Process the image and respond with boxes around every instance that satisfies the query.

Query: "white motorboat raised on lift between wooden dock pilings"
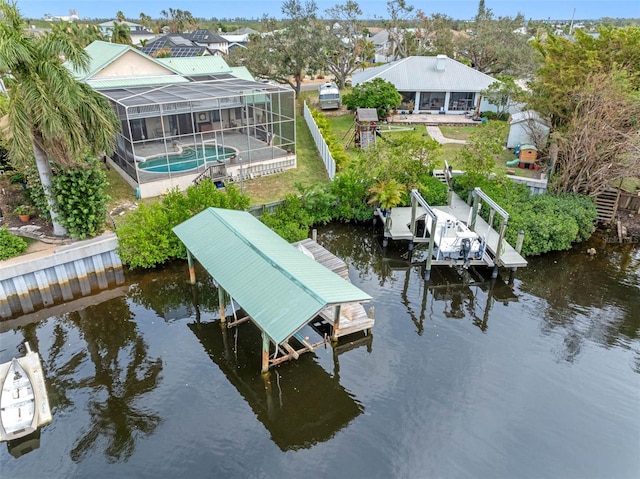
[418,208,484,267]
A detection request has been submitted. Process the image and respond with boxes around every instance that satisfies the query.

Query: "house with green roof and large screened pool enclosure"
[66,41,296,198]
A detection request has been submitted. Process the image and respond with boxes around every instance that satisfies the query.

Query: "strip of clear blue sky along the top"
[10,0,640,20]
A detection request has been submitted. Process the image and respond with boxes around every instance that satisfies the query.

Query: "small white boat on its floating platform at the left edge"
[0,343,52,441]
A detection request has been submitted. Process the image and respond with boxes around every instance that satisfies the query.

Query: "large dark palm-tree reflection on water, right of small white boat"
[63,297,162,462]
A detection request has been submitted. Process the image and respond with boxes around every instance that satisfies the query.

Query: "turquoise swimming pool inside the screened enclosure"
[138,145,237,173]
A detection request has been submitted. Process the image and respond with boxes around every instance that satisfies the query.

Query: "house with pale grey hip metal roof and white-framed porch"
[352,55,498,114]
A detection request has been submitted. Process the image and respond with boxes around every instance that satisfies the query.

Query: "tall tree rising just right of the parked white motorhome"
[322,0,364,90]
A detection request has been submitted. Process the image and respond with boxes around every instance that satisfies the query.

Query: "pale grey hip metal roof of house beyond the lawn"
[352,56,497,92]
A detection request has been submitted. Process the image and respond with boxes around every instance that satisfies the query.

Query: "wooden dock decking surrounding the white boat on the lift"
[378,193,527,274]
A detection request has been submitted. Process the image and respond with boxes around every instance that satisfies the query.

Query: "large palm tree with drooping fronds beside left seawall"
[0,1,120,236]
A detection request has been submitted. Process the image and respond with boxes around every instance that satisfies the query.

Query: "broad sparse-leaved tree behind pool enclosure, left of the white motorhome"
[232,0,324,95]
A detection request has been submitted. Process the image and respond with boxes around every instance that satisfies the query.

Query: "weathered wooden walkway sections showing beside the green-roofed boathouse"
[294,239,375,340]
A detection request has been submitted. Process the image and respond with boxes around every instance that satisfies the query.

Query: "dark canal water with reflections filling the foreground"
[0,225,640,479]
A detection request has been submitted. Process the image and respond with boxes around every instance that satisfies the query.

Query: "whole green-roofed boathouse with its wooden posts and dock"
[173,208,374,373]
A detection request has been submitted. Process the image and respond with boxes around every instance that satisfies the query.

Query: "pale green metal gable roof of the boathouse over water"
[173,208,371,344]
